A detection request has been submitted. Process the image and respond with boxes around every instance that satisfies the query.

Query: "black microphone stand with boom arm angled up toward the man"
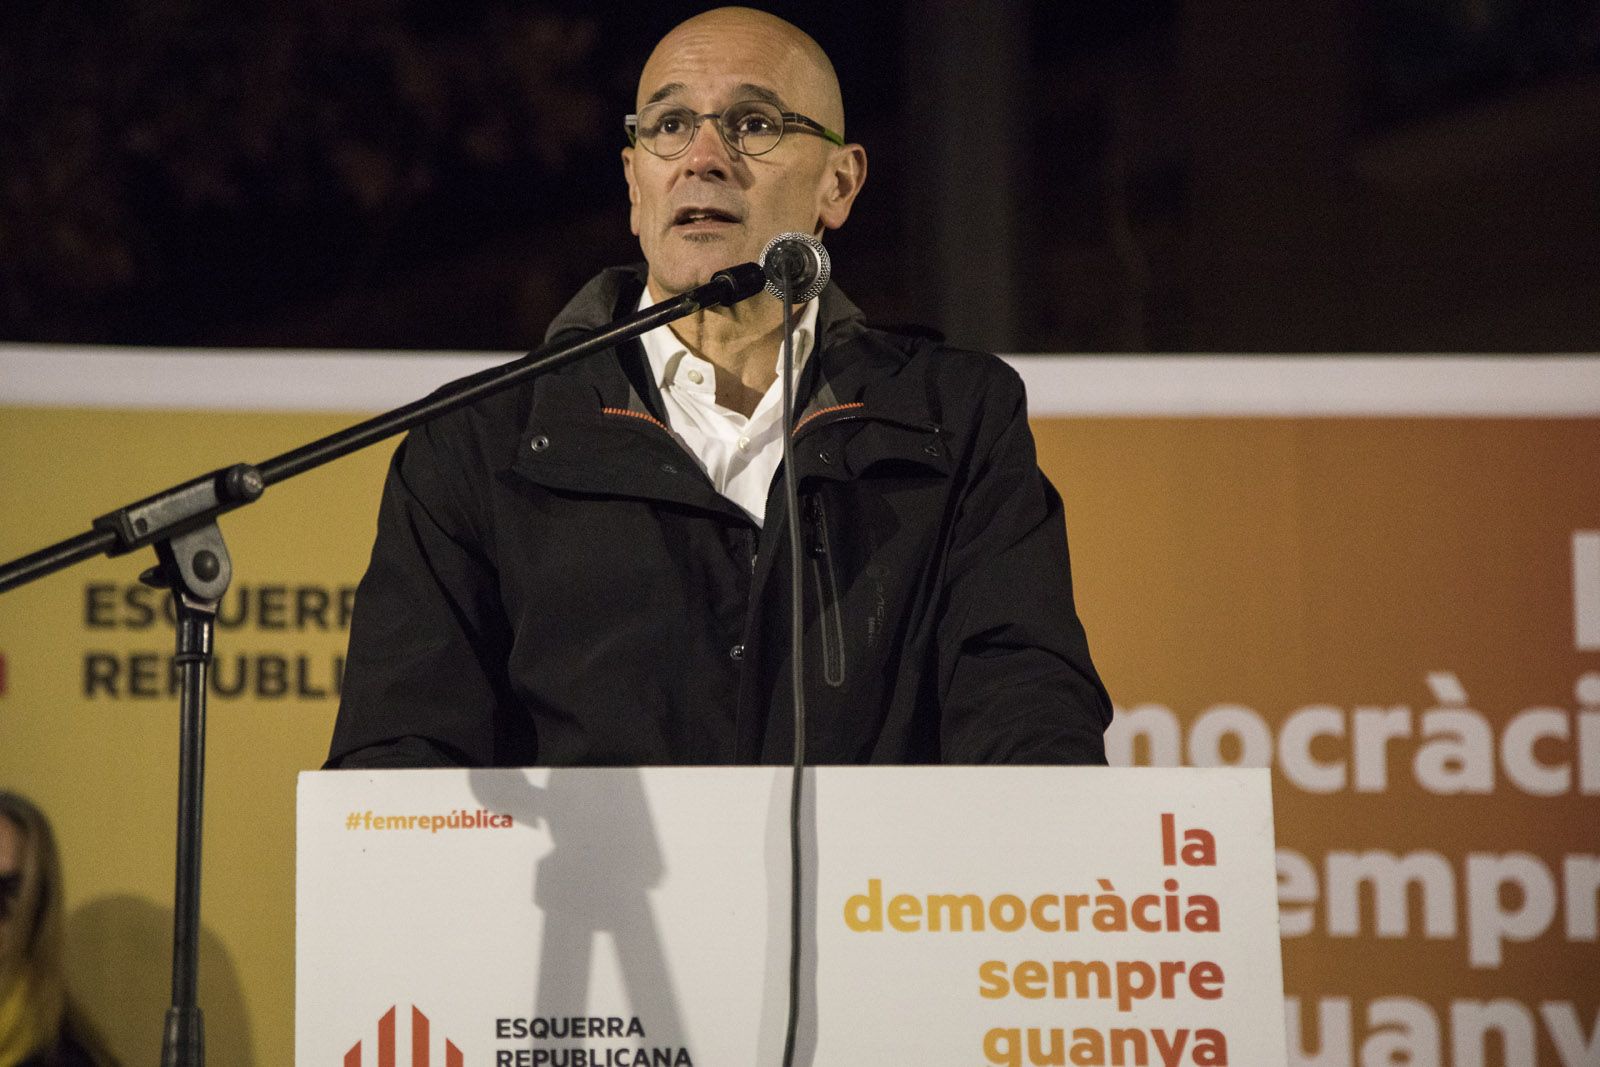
[0,262,766,1067]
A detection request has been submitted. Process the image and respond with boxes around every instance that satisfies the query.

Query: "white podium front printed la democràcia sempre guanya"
[294,766,1285,1067]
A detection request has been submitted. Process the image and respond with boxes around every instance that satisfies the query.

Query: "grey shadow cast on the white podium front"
[470,768,685,1046]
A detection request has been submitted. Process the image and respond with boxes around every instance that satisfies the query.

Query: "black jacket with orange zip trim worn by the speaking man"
[328,269,1110,766]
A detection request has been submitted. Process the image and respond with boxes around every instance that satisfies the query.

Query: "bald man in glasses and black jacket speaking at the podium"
[318,8,1110,768]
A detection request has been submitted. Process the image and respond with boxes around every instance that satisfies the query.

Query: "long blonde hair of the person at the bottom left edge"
[0,790,115,1067]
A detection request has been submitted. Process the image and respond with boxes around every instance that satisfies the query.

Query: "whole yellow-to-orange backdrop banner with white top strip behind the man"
[0,347,1600,1067]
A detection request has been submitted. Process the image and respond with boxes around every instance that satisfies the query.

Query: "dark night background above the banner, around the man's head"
[0,0,1600,352]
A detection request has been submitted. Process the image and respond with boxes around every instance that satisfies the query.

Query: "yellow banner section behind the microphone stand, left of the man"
[0,408,392,1067]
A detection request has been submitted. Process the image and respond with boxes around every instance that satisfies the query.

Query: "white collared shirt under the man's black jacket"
[638,286,816,525]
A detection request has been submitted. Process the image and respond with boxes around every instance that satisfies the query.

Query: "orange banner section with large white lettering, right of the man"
[1037,419,1600,1065]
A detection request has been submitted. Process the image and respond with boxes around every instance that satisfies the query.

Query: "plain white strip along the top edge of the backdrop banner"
[0,344,1600,418]
